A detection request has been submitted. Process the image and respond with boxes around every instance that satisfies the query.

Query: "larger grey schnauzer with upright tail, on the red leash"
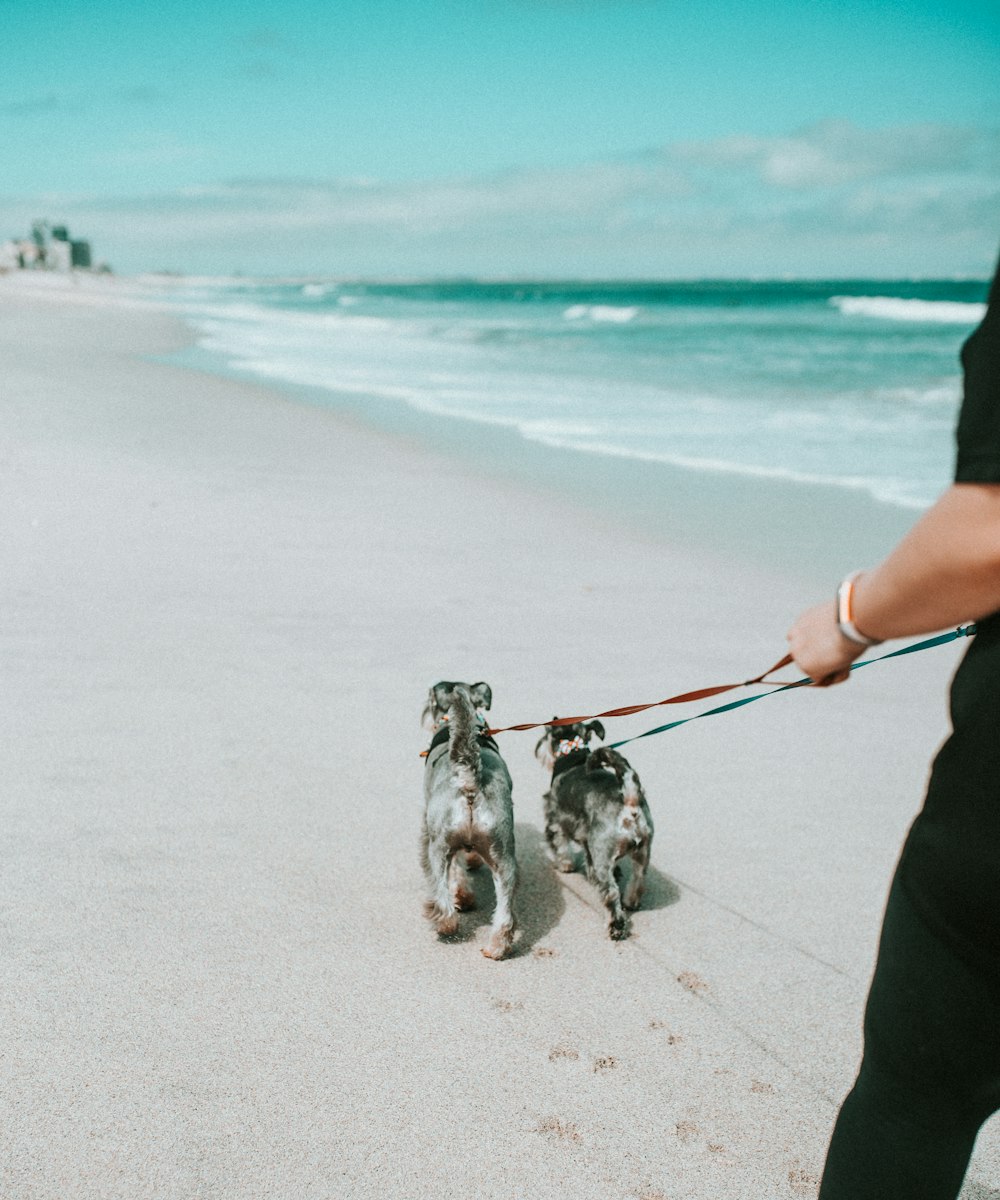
[420,682,517,959]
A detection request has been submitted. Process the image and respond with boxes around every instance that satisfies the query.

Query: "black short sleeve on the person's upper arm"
[954,255,1000,484]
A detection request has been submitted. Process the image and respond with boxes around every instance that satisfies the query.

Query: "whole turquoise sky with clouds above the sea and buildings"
[0,0,1000,278]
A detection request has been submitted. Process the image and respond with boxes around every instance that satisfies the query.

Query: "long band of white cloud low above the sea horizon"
[0,121,1000,276]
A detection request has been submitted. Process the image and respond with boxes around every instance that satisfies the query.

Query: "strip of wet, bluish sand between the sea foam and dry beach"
[163,319,922,590]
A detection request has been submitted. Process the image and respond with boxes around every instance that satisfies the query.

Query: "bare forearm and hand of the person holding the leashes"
[788,484,1000,685]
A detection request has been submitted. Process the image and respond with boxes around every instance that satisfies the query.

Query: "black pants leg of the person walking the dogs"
[819,877,1000,1200]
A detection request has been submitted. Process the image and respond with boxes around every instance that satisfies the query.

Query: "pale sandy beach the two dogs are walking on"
[0,276,1000,1200]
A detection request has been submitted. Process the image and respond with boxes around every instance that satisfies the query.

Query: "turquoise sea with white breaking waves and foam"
[162,280,988,510]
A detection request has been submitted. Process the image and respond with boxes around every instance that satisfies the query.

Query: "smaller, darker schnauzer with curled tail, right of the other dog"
[534,721,653,941]
